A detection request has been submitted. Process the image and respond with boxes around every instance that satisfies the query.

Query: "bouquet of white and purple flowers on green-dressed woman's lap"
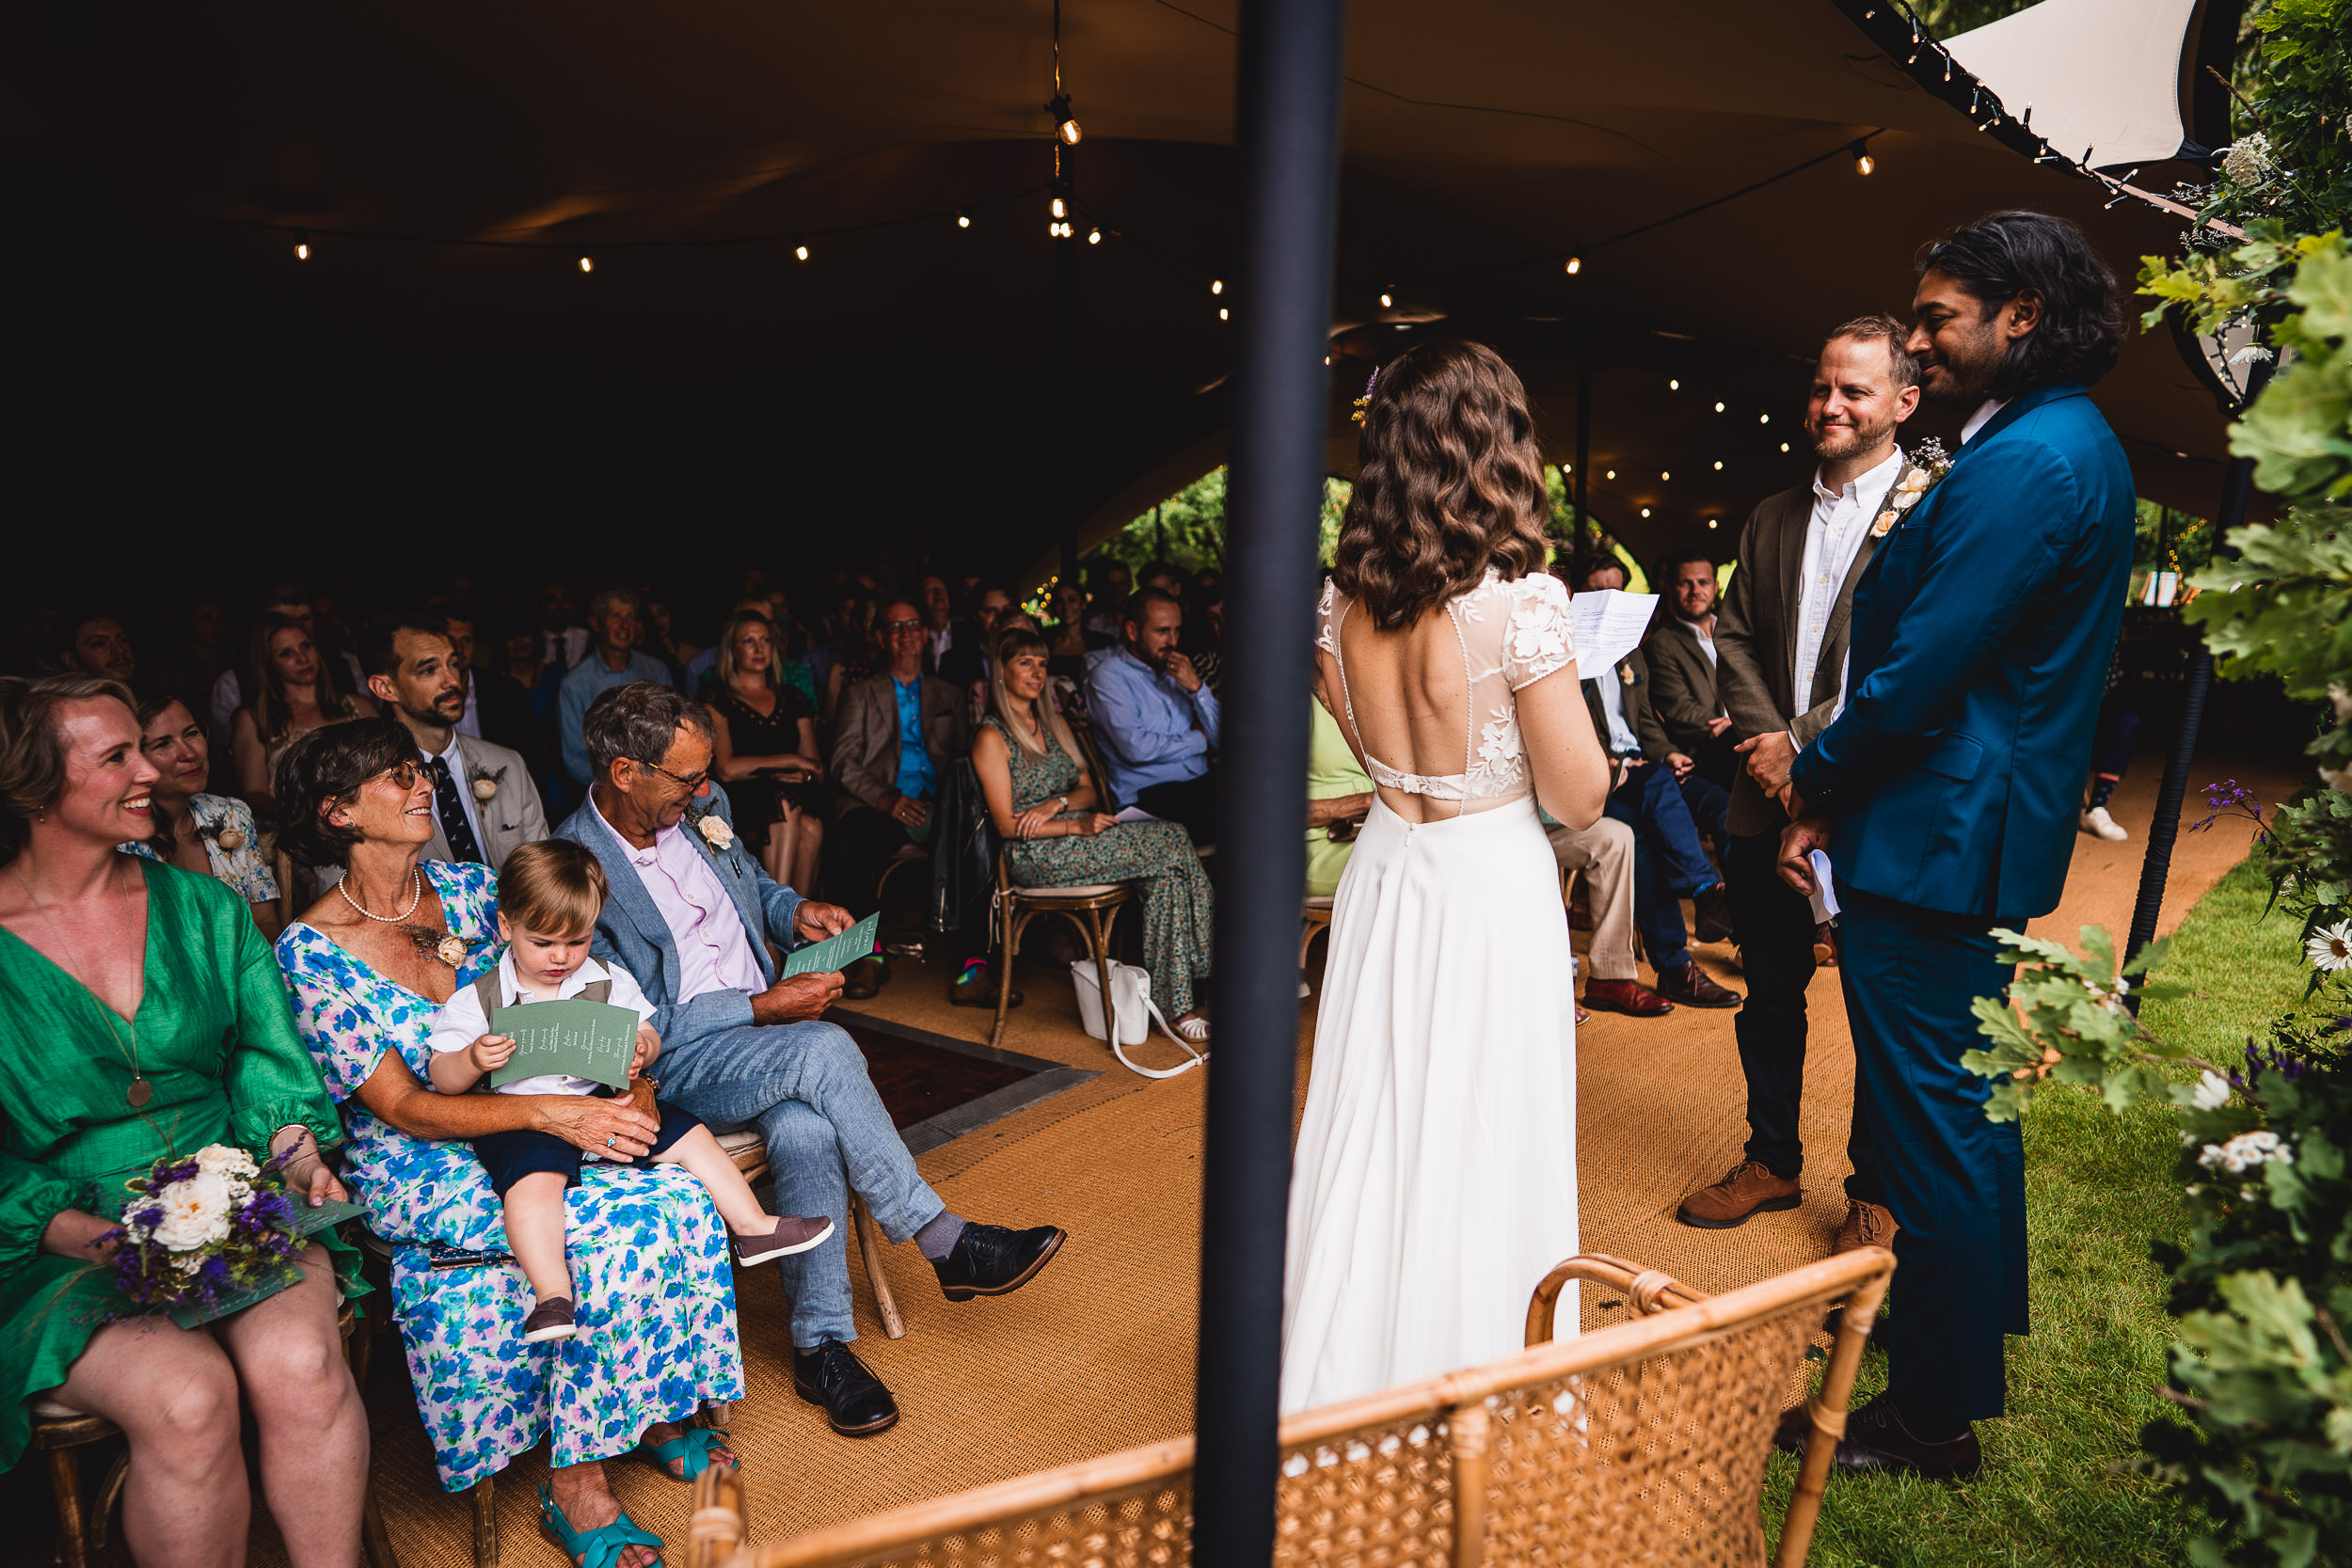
[102,1143,301,1322]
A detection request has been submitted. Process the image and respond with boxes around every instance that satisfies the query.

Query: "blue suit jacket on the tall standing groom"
[1790,386,2134,919]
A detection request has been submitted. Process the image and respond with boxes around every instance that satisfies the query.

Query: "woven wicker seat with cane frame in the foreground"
[687,1248,1896,1568]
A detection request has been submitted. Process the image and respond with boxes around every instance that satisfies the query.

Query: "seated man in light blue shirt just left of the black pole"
[1087,588,1223,844]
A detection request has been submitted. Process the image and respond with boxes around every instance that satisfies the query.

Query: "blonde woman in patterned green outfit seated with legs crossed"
[972,626,1212,1044]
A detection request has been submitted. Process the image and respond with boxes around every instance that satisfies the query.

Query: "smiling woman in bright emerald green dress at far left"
[0,674,367,1568]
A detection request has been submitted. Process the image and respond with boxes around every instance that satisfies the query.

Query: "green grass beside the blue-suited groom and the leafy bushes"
[1764,863,2310,1568]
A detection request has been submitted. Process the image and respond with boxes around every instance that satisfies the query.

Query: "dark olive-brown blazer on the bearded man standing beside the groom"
[1715,483,1910,834]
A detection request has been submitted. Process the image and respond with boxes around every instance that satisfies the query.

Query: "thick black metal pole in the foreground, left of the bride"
[1193,0,1348,1568]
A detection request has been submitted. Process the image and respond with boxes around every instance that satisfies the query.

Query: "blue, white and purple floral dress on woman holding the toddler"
[278,861,743,1491]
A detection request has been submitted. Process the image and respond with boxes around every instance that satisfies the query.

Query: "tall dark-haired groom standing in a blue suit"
[1781,212,2134,1479]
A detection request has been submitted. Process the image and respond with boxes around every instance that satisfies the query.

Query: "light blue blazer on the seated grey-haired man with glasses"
[555,785,800,1049]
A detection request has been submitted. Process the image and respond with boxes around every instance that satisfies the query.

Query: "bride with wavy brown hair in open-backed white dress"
[1282,343,1609,1413]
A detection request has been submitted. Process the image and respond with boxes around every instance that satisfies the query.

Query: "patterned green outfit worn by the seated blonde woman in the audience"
[981,717,1212,1018]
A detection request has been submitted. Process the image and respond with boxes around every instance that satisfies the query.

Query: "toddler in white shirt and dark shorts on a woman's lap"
[426,839,833,1345]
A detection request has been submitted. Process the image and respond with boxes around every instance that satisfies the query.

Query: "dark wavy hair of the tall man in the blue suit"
[1919,212,2124,397]
